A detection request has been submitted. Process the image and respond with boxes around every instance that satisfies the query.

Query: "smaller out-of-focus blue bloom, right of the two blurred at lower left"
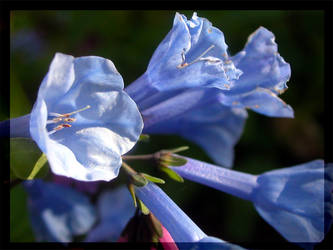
[85,187,135,242]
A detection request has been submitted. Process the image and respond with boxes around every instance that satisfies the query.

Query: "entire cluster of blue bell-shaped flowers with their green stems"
[7,13,333,249]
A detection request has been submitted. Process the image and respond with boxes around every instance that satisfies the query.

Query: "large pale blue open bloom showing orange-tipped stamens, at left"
[30,53,143,181]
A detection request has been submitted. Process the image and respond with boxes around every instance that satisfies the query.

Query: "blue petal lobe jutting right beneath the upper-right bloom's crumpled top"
[221,88,294,118]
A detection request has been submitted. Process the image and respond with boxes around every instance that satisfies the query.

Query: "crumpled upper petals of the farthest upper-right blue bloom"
[230,27,291,94]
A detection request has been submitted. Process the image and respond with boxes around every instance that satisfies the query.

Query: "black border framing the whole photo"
[0,0,333,250]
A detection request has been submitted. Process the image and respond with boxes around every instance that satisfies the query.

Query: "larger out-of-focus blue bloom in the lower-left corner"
[23,179,96,242]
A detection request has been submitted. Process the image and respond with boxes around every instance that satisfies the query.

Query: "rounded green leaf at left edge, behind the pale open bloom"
[10,138,49,180]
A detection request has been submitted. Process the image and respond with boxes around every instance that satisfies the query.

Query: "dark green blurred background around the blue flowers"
[8,10,326,248]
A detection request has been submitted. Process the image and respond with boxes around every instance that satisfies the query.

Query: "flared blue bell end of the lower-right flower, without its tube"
[254,160,324,243]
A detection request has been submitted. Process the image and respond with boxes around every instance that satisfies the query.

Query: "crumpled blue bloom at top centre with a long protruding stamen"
[126,13,241,103]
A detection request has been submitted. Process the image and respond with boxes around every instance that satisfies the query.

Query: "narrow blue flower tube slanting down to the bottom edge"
[135,183,243,249]
